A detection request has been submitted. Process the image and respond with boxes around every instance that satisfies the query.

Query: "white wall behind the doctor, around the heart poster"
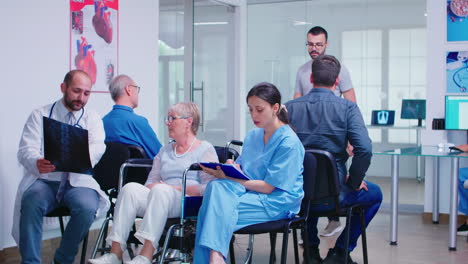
[0,0,160,249]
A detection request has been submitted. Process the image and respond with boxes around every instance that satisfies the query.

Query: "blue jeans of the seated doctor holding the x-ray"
[19,180,99,264]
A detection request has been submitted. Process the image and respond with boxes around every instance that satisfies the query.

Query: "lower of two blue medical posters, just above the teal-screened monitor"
[446,50,468,94]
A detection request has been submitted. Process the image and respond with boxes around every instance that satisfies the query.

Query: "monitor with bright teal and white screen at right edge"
[445,95,468,130]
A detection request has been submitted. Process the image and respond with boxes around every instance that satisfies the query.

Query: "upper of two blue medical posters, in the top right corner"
[447,0,468,42]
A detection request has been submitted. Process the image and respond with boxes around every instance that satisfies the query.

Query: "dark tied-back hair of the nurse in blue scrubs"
[246,82,289,124]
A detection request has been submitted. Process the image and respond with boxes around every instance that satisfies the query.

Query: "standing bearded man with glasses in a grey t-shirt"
[294,26,356,102]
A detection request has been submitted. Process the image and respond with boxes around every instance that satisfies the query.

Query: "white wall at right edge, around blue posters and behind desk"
[422,1,468,213]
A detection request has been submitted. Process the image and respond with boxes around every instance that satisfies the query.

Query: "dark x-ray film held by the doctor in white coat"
[42,116,93,175]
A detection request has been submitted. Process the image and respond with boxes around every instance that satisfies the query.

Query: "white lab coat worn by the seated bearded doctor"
[12,99,110,243]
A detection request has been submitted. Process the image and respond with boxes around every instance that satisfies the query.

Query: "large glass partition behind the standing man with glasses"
[246,0,426,144]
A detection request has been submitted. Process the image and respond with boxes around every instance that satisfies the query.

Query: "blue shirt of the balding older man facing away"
[102,105,161,159]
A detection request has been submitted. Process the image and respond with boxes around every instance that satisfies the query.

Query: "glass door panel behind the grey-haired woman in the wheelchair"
[157,0,240,145]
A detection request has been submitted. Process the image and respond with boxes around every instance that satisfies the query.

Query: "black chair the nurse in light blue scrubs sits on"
[229,151,317,264]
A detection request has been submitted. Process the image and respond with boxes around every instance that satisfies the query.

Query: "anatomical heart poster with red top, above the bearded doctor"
[70,0,119,92]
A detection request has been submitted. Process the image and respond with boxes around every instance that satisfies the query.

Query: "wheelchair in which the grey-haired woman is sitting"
[91,141,242,264]
